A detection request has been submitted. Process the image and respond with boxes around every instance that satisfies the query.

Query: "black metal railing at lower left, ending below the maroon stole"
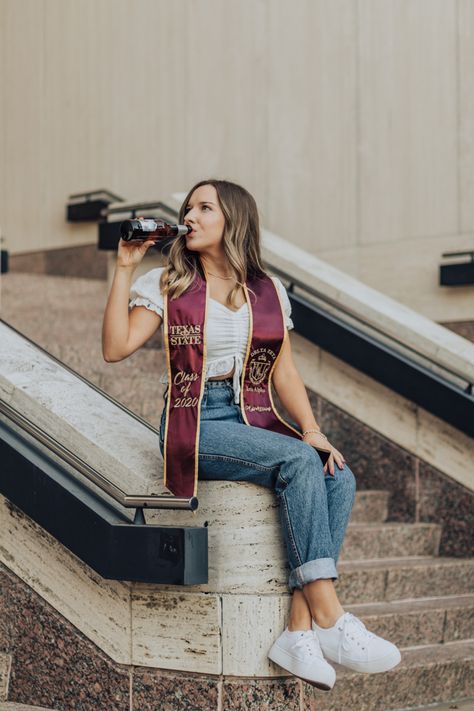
[0,413,208,585]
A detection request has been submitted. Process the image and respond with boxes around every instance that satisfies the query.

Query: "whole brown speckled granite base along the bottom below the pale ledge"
[0,566,300,711]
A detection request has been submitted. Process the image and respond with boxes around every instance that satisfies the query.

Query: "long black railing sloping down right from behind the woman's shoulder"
[267,264,474,437]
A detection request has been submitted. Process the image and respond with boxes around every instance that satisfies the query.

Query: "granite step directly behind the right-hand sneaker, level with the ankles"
[346,594,474,648]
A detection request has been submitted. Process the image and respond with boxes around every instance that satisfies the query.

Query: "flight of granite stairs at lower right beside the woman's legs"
[303,482,474,711]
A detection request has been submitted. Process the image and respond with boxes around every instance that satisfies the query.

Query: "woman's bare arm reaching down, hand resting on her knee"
[272,334,344,474]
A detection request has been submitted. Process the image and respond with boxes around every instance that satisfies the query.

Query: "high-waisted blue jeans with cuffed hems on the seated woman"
[160,379,356,591]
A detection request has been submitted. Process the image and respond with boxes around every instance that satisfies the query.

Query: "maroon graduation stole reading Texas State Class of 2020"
[163,274,329,497]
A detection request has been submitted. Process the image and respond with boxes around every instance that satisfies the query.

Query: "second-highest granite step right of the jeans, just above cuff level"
[340,523,442,560]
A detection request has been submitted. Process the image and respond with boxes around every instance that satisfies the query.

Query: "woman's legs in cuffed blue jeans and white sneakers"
[160,384,399,689]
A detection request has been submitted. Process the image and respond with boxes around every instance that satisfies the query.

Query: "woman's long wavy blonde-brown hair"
[160,178,266,307]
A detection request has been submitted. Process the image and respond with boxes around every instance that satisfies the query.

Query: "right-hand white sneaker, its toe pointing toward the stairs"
[313,612,402,674]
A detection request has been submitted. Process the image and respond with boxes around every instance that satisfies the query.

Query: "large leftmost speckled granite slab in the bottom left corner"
[0,567,130,711]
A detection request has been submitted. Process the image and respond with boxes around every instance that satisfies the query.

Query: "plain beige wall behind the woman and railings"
[0,0,474,320]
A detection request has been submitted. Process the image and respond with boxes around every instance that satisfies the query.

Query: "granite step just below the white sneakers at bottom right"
[304,640,474,711]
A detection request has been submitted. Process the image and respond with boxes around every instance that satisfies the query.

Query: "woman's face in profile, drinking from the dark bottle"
[184,185,225,252]
